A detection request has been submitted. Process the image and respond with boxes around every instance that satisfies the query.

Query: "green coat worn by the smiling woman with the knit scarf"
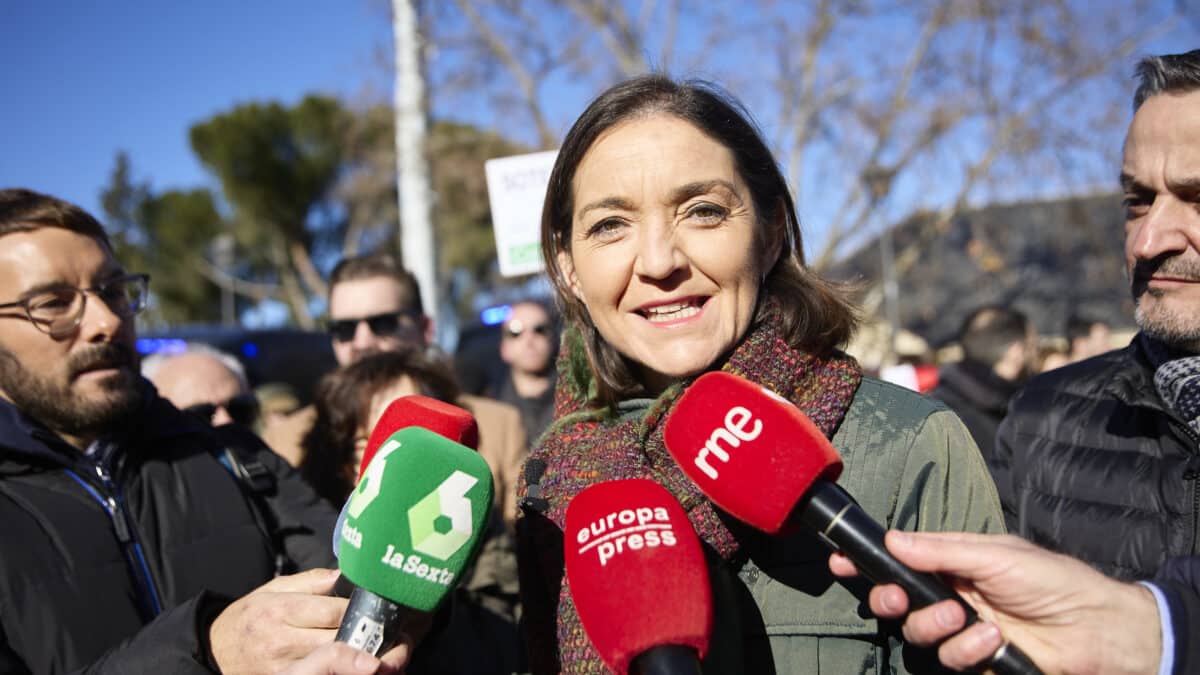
[704,377,1004,675]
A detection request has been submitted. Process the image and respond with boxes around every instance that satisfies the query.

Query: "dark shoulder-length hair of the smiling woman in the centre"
[541,74,858,405]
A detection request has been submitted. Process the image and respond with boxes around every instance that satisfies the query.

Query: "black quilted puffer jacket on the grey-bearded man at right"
[989,339,1200,579]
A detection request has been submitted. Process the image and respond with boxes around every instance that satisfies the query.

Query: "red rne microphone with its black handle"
[664,372,1040,675]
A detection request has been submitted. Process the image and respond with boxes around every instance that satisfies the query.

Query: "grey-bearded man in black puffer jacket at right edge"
[991,50,1200,579]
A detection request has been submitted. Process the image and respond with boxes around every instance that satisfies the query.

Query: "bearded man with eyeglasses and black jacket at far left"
[0,190,406,673]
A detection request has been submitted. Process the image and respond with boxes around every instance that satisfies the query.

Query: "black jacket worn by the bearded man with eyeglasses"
[0,382,335,673]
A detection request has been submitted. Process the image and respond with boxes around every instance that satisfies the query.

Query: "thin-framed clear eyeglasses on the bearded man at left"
[0,274,150,338]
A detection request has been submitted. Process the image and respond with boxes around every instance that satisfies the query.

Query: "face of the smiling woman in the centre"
[559,114,779,392]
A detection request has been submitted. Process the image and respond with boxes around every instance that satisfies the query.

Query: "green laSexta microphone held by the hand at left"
[336,426,493,655]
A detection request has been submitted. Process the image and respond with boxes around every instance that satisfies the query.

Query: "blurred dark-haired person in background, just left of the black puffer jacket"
[929,305,1039,460]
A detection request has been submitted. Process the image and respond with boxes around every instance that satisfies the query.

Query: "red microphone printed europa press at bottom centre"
[563,478,713,675]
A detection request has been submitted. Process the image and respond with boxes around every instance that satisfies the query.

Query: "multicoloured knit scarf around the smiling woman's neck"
[522,307,863,673]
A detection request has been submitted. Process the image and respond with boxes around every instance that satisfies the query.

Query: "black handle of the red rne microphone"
[799,480,1042,675]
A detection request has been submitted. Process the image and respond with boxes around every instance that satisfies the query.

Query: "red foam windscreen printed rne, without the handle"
[664,372,841,534]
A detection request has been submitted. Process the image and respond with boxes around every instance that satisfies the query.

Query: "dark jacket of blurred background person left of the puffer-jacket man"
[929,360,1019,461]
